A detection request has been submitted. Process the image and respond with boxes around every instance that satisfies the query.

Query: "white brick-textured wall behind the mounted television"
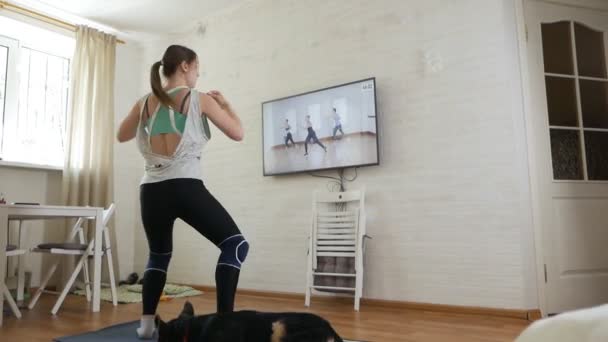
[127,0,538,309]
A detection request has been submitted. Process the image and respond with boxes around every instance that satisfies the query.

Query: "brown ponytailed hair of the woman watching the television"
[150,45,196,106]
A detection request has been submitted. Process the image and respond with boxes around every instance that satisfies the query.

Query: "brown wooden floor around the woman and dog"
[0,293,528,342]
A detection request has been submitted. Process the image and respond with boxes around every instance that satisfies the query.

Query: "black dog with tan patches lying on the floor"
[156,302,342,342]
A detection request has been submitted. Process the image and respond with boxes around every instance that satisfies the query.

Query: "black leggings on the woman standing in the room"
[140,178,244,315]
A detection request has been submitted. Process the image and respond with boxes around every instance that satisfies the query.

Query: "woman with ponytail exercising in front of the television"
[117,45,249,339]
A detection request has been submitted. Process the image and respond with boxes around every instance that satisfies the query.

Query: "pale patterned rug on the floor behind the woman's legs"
[73,284,203,304]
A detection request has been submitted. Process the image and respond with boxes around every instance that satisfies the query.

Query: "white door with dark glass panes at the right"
[525,1,608,314]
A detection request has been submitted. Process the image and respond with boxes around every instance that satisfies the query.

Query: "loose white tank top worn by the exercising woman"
[136,87,210,184]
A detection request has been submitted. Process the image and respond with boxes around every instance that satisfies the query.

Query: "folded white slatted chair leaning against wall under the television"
[305,190,368,311]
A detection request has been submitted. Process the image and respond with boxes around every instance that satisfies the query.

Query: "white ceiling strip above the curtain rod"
[9,0,245,38]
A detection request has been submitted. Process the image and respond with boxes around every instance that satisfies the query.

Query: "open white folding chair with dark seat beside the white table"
[28,204,117,315]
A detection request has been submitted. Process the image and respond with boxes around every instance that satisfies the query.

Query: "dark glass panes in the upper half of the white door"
[542,21,608,181]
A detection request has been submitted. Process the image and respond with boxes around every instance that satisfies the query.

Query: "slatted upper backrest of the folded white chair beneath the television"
[311,190,365,268]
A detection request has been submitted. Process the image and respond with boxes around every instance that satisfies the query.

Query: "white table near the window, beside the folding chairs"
[0,205,103,326]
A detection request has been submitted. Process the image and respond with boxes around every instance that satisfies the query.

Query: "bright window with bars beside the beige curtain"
[0,17,74,166]
